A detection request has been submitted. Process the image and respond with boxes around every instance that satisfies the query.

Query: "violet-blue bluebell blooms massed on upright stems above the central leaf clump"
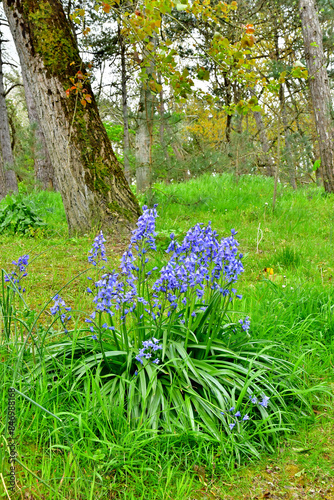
[86,205,248,352]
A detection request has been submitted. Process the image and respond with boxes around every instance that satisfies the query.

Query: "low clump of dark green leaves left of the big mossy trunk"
[0,195,46,236]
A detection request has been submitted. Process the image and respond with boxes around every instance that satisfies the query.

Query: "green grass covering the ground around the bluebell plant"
[0,175,334,500]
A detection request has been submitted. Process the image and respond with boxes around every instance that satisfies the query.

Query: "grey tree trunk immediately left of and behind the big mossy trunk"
[22,68,56,190]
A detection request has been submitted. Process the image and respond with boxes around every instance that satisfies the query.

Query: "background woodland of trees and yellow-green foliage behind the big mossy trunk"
[1,1,334,199]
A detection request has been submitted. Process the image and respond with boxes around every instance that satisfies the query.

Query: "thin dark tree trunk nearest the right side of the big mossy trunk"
[118,23,131,183]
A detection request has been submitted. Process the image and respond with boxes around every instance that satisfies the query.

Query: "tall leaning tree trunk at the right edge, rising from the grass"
[299,0,334,193]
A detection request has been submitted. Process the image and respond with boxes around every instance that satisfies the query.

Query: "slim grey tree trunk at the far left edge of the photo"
[0,33,18,198]
